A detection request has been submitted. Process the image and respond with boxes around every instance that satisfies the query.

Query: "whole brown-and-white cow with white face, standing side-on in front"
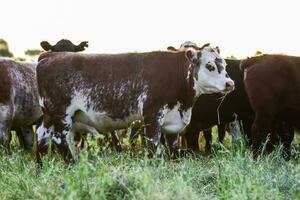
[37,46,234,159]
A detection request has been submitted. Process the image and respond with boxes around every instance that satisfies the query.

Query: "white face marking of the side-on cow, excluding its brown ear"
[194,47,234,96]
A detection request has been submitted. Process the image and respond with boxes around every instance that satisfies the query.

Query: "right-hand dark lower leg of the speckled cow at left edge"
[16,126,34,150]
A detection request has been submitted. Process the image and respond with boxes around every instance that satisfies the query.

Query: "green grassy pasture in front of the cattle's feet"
[0,131,300,200]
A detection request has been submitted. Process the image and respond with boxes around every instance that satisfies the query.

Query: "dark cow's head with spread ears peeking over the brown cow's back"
[41,39,88,52]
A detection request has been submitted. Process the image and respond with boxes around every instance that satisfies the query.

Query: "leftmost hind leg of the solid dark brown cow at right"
[252,111,274,158]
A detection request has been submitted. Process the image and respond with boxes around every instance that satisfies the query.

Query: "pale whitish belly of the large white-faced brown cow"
[74,112,143,132]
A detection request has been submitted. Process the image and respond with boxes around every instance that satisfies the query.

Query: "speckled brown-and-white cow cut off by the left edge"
[0,59,42,149]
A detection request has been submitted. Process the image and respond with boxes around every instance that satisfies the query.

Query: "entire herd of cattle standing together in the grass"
[0,40,300,162]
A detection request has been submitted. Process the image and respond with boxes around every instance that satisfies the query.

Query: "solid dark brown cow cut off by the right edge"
[241,55,300,157]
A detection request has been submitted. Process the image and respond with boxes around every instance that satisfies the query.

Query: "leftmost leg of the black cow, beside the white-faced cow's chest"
[184,124,200,152]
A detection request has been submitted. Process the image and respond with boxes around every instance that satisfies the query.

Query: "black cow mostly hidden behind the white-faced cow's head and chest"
[167,41,253,153]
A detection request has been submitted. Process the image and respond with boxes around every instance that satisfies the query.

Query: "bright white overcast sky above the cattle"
[0,0,300,58]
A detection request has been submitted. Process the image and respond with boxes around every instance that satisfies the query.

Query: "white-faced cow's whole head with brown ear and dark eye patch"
[185,44,234,96]
